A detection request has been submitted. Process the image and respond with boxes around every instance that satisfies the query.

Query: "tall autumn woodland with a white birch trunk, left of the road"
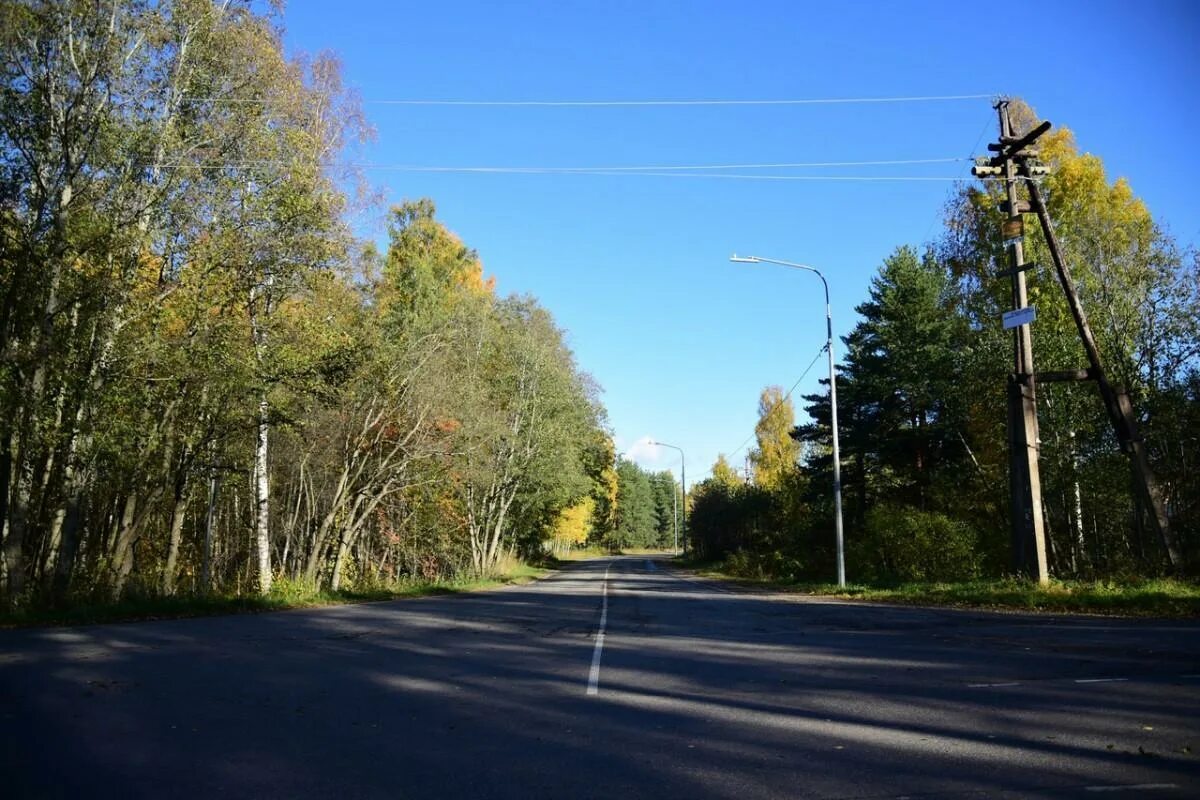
[0,0,619,607]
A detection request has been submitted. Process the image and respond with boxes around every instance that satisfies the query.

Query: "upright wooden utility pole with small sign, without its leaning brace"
[972,100,1050,583]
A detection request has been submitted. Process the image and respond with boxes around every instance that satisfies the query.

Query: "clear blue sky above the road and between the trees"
[284,0,1200,483]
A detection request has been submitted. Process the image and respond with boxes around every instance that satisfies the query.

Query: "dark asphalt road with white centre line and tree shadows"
[0,557,1200,800]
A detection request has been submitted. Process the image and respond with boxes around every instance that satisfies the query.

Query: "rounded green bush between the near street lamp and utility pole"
[854,506,979,581]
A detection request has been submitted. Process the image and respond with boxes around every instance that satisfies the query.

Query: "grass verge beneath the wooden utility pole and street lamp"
[680,563,1200,616]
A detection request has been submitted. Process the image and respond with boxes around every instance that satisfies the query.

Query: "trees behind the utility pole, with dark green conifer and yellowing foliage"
[689,103,1200,582]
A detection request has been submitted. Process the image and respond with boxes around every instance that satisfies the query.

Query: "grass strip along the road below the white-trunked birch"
[0,558,550,628]
